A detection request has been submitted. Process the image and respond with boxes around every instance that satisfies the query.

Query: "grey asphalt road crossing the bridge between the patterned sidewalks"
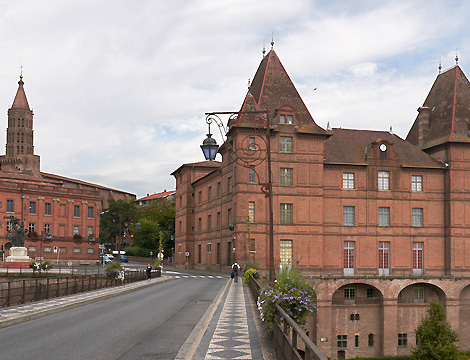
[0,274,227,360]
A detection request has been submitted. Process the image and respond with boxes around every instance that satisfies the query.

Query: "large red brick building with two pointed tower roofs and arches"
[173,50,470,358]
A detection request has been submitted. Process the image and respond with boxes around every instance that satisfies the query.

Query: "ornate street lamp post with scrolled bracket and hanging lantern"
[201,110,274,284]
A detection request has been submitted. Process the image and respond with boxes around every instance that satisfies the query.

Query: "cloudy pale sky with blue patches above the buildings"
[0,0,470,198]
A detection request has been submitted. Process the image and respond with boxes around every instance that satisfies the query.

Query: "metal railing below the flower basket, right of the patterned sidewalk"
[248,275,328,360]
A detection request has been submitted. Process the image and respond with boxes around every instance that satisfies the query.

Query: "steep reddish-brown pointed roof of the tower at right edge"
[406,65,470,149]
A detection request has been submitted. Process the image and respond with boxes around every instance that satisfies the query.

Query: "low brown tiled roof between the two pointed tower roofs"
[324,128,445,168]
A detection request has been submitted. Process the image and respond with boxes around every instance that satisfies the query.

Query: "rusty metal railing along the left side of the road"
[0,270,161,307]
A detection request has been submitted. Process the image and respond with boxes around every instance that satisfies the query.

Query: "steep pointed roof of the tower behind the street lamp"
[229,50,330,136]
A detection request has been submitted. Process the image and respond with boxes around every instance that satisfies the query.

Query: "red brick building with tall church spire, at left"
[0,76,135,263]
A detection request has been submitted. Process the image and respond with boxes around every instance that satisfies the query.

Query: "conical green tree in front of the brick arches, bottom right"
[412,299,462,360]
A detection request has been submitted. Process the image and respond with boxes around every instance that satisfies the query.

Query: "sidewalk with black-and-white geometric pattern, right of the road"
[175,277,274,360]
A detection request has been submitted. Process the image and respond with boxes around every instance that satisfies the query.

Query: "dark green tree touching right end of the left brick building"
[100,199,136,243]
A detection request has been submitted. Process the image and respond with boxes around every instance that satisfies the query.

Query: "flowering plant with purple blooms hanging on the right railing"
[257,267,316,330]
